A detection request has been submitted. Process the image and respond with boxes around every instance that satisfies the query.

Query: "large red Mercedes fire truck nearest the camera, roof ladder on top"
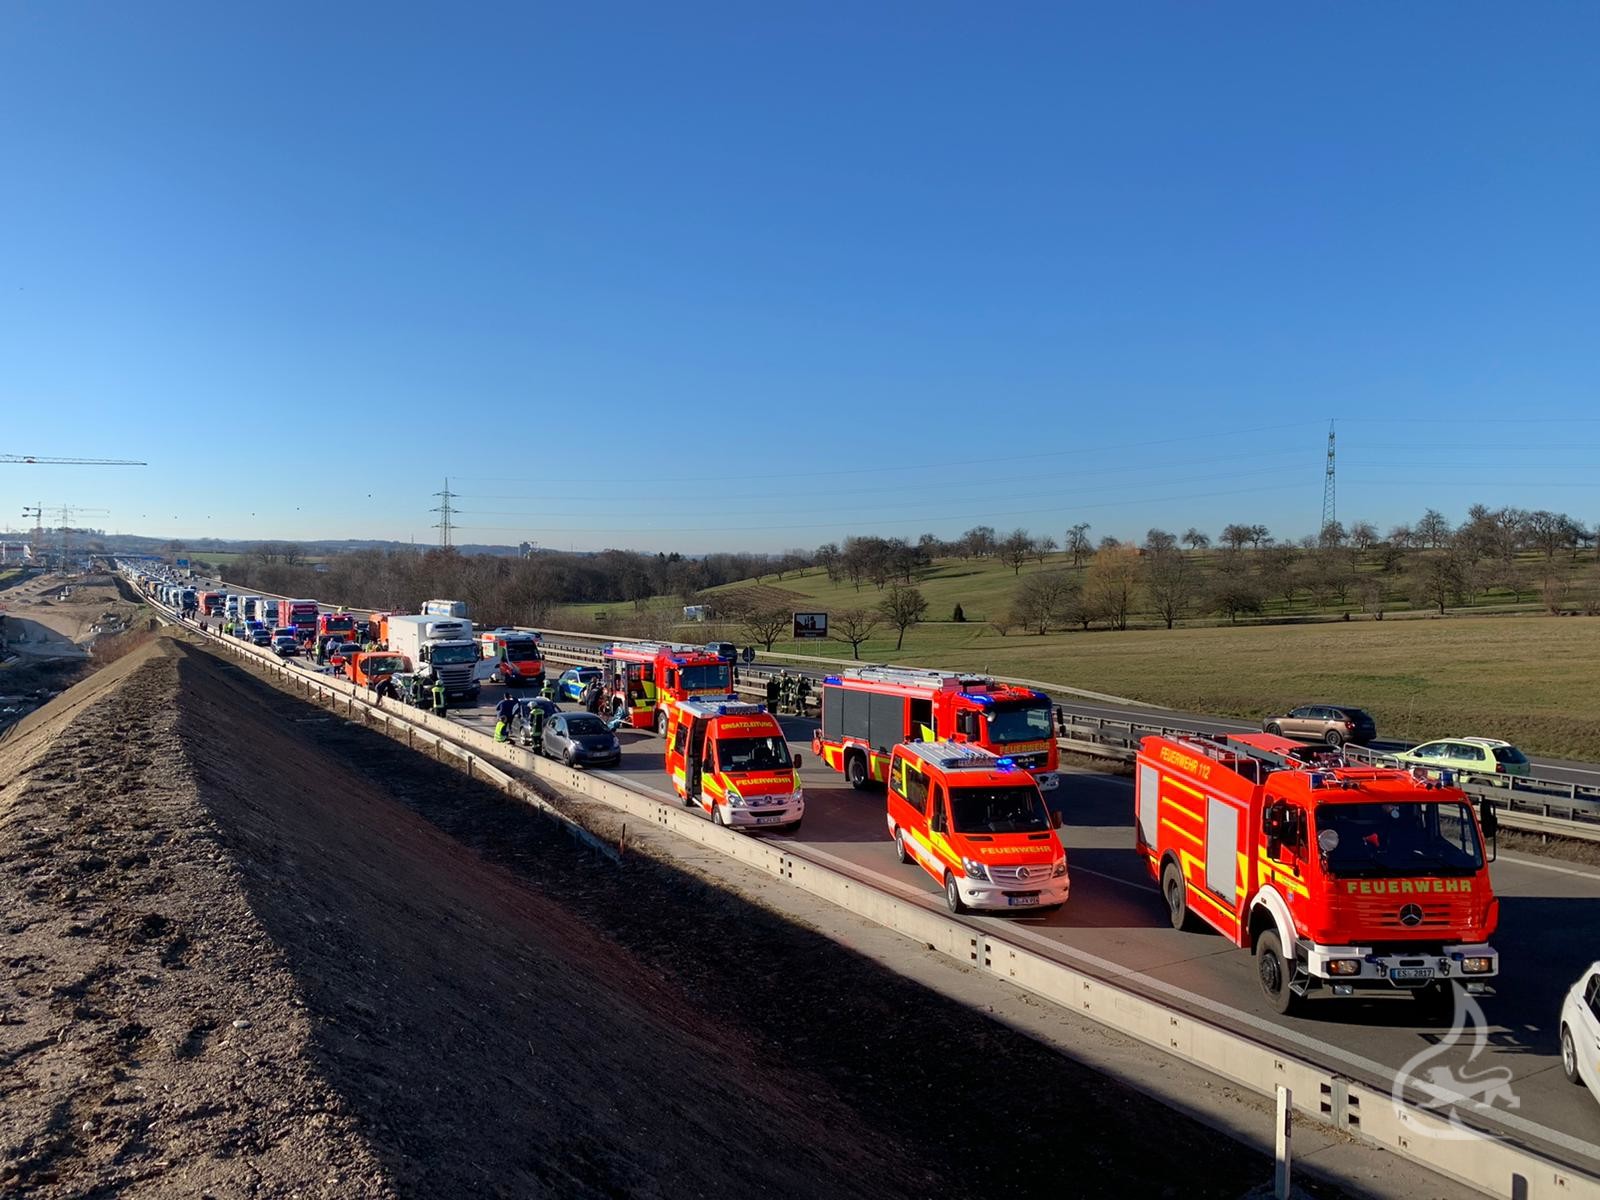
[1134,733,1499,1013]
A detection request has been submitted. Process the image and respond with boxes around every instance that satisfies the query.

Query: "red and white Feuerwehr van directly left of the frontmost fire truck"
[886,741,1069,912]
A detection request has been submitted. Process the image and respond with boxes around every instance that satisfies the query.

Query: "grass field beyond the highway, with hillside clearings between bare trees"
[553,562,1600,760]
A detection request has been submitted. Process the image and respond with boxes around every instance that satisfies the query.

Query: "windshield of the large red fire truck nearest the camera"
[1315,802,1483,877]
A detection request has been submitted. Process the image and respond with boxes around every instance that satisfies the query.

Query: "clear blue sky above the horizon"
[0,3,1600,552]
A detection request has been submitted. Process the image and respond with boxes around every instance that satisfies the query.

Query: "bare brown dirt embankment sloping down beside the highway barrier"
[0,637,1286,1200]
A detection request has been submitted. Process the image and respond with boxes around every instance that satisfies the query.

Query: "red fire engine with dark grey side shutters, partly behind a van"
[811,667,1061,792]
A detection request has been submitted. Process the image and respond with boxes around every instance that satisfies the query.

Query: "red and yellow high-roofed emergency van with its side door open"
[662,699,805,829]
